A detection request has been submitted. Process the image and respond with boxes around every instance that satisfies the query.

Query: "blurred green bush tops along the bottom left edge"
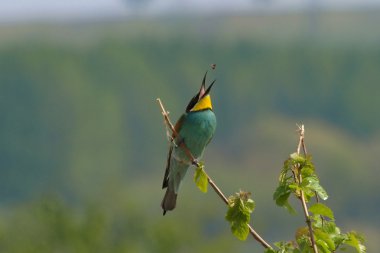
[0,196,238,253]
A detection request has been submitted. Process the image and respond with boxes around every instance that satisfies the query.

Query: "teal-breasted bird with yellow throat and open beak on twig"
[161,71,216,215]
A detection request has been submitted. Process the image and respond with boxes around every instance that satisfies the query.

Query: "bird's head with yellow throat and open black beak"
[186,71,216,112]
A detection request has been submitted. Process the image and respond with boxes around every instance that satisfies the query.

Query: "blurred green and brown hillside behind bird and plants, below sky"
[0,5,380,253]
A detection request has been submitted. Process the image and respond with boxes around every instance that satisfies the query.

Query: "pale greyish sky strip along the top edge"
[0,0,380,22]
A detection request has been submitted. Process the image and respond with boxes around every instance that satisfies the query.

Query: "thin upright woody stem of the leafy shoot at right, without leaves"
[297,124,318,253]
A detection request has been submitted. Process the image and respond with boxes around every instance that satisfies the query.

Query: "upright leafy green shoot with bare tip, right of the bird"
[272,125,366,253]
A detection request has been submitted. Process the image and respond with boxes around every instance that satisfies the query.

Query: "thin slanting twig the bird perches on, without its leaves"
[157,98,272,249]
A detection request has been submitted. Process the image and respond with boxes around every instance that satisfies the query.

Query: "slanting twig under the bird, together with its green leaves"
[157,98,272,249]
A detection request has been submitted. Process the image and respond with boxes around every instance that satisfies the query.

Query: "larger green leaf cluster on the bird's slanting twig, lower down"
[226,191,255,240]
